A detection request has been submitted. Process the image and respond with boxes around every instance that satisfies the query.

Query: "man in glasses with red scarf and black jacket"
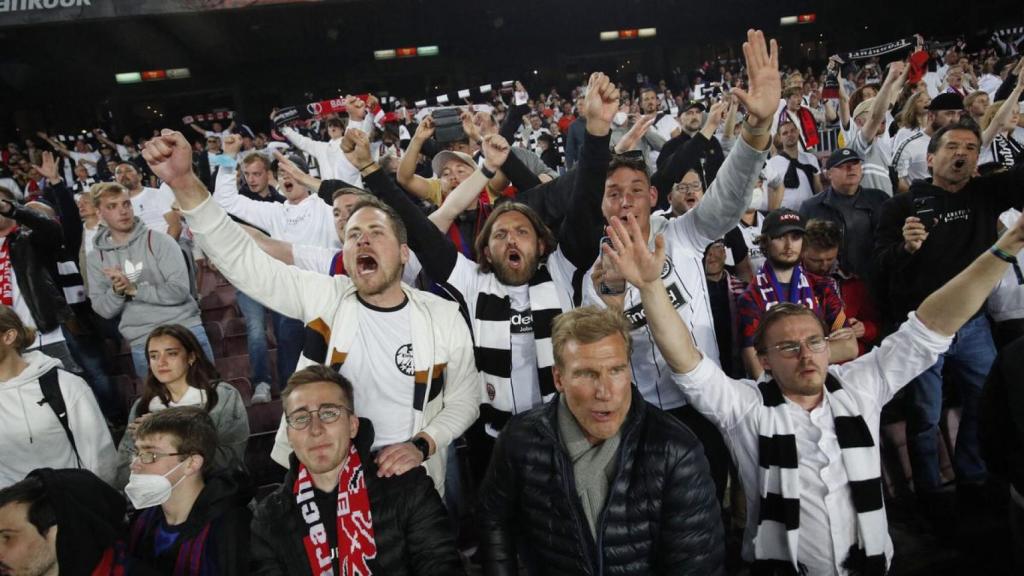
[249,366,465,576]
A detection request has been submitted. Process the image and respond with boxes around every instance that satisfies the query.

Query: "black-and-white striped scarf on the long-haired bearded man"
[473,263,562,411]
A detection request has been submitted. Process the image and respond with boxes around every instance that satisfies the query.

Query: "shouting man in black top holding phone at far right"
[874,118,1024,527]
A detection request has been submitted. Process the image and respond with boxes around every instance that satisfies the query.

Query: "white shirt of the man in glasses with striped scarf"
[673,313,952,576]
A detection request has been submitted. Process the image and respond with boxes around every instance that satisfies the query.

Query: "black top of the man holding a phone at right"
[874,164,1024,322]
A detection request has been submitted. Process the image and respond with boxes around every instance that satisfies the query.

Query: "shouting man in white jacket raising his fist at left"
[143,130,480,492]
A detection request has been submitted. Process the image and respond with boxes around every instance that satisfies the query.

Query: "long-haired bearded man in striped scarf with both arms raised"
[350,73,618,478]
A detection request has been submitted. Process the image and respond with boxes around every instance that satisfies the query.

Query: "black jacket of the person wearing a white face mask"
[128,471,254,574]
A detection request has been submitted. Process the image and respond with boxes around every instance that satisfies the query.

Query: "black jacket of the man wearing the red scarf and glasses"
[249,419,466,576]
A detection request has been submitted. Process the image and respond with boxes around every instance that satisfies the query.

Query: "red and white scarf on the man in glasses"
[293,444,377,576]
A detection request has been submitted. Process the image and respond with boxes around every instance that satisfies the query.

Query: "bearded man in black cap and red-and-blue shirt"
[736,208,857,378]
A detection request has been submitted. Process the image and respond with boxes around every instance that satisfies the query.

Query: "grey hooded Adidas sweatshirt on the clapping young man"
[86,217,202,346]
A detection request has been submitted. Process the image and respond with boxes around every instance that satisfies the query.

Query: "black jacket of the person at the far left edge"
[4,198,71,332]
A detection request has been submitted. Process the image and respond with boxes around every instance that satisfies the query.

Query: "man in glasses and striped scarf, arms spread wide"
[604,184,1024,576]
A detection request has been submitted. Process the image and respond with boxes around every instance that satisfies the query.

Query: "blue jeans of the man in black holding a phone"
[906,316,995,487]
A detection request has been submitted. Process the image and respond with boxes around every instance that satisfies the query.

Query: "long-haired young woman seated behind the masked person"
[117,324,249,488]
